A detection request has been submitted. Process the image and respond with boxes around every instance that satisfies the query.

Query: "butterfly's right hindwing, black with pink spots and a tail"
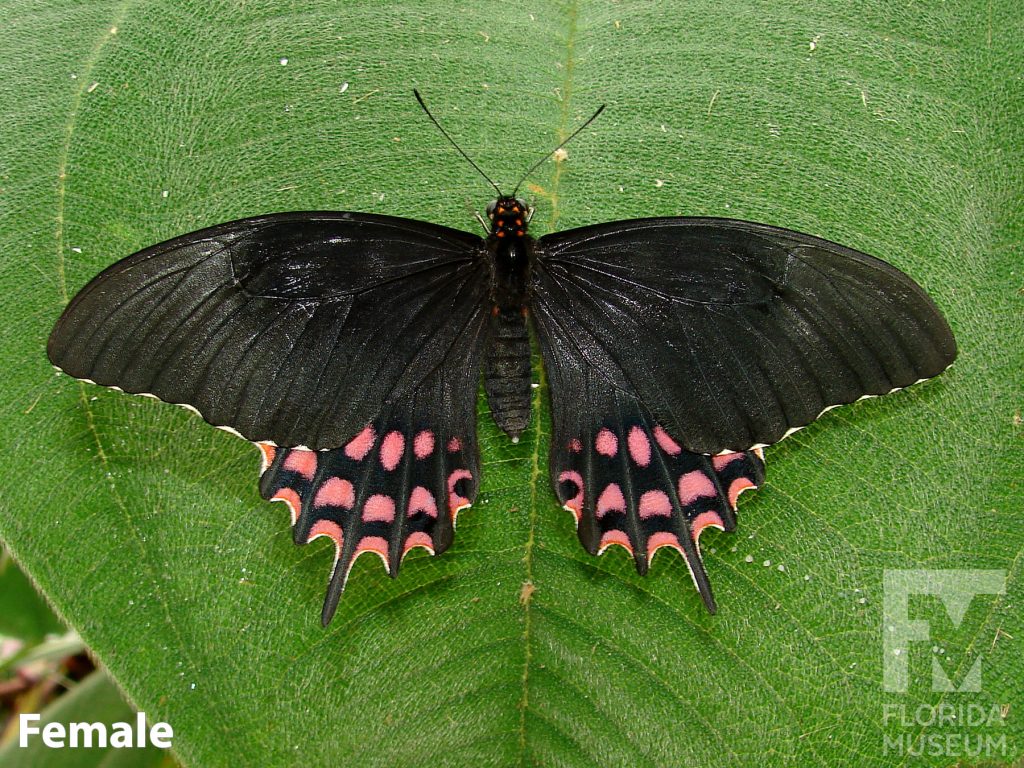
[535,325,764,612]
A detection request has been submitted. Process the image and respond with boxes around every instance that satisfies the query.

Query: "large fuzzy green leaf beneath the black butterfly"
[0,0,1024,767]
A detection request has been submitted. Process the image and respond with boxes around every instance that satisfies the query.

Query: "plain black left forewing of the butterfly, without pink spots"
[47,213,488,449]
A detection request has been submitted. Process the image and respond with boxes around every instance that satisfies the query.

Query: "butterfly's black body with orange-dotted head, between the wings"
[483,197,534,439]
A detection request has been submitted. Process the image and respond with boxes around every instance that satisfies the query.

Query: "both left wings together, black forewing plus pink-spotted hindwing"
[47,213,489,621]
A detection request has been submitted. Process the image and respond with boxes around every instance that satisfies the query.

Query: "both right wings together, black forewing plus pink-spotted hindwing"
[531,218,956,608]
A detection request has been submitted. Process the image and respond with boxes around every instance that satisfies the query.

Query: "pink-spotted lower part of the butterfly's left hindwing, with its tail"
[257,409,477,626]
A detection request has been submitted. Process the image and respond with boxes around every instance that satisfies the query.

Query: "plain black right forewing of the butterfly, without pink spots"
[532,218,956,454]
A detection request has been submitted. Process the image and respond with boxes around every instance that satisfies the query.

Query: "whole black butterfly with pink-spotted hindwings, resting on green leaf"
[47,94,956,625]
